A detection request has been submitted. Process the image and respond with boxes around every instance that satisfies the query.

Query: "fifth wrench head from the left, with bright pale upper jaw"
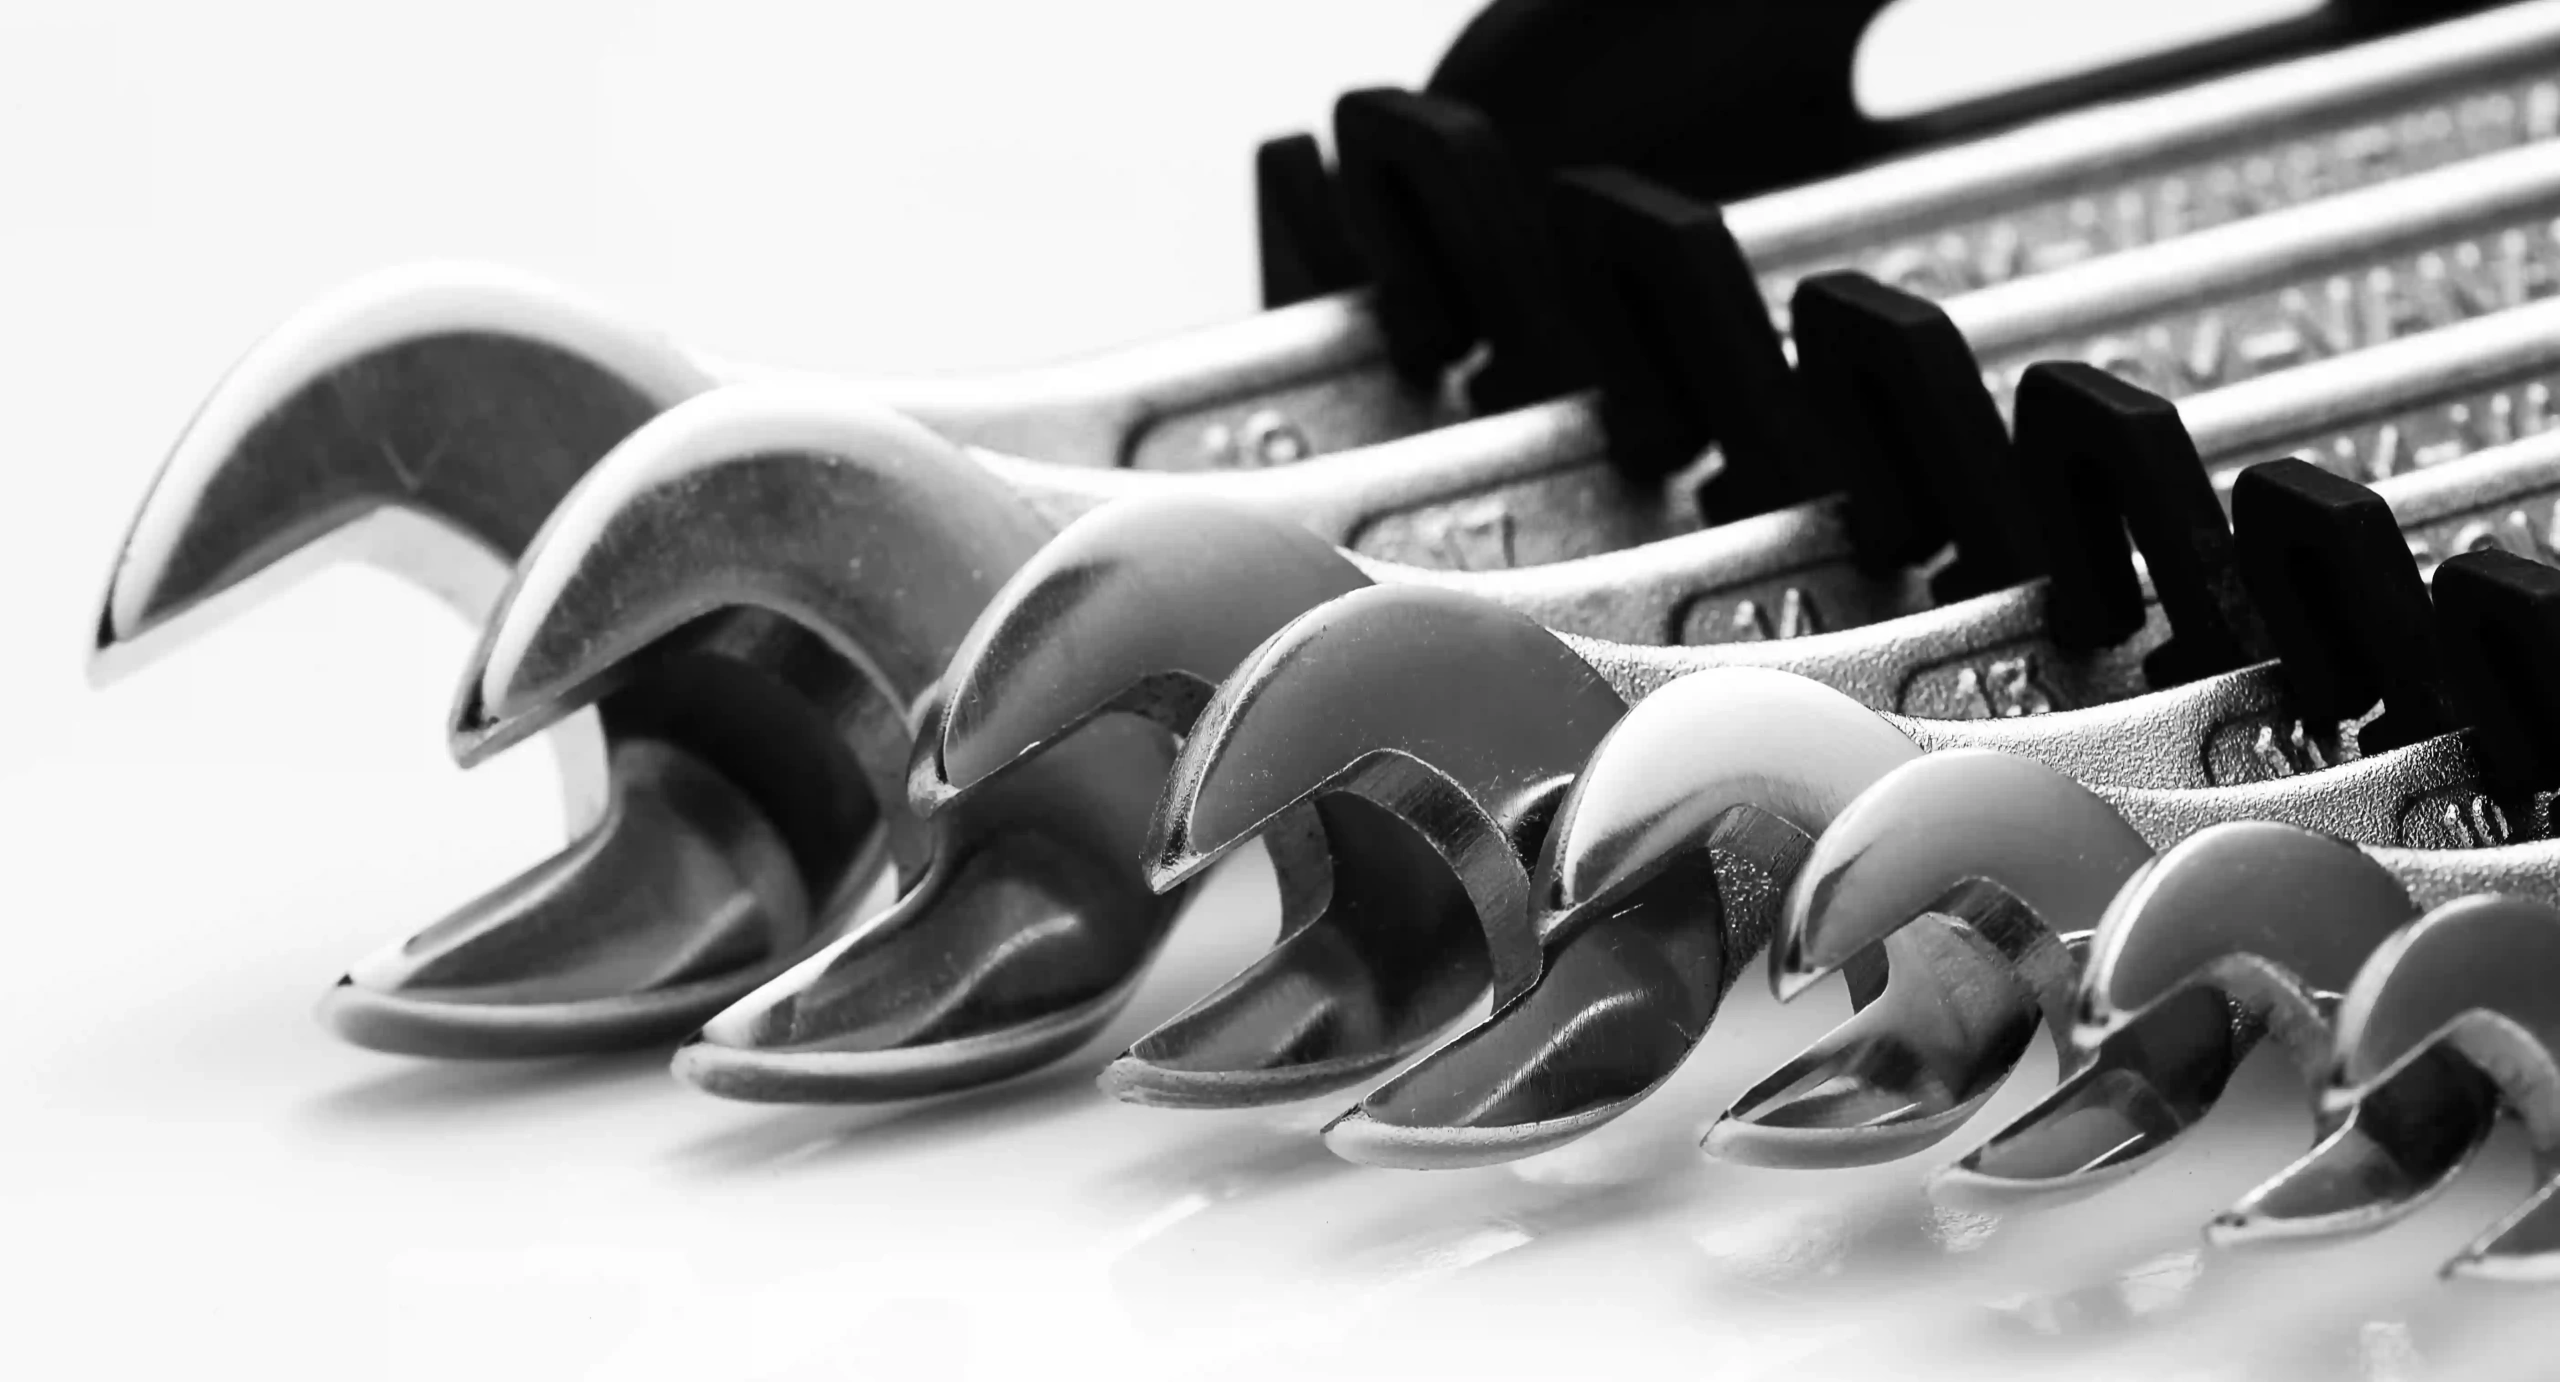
[1326,668,1920,1167]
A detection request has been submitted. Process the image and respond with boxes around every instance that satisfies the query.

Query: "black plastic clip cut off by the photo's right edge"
[2435,548,2560,809]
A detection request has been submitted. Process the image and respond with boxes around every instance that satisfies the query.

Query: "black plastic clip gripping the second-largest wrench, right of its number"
[1549,169,1838,511]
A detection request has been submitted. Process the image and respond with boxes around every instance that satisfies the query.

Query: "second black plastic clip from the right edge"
[2232,458,2455,752]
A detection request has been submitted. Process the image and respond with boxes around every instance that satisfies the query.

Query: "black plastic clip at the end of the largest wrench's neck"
[1334,87,1590,409]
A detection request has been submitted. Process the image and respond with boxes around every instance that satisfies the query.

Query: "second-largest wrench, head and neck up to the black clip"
[422,386,1677,1100]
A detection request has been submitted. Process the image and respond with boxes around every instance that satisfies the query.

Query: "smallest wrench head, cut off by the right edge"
[2322,896,2560,1282]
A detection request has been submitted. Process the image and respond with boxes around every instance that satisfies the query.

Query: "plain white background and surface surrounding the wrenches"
[0,0,2560,1379]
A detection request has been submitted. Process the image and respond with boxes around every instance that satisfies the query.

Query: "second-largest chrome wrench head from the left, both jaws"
[456,386,1178,1098]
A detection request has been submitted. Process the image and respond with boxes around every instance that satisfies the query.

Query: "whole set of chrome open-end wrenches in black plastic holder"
[97,0,2560,1280]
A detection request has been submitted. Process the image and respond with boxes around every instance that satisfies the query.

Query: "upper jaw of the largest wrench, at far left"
[92,266,712,683]
